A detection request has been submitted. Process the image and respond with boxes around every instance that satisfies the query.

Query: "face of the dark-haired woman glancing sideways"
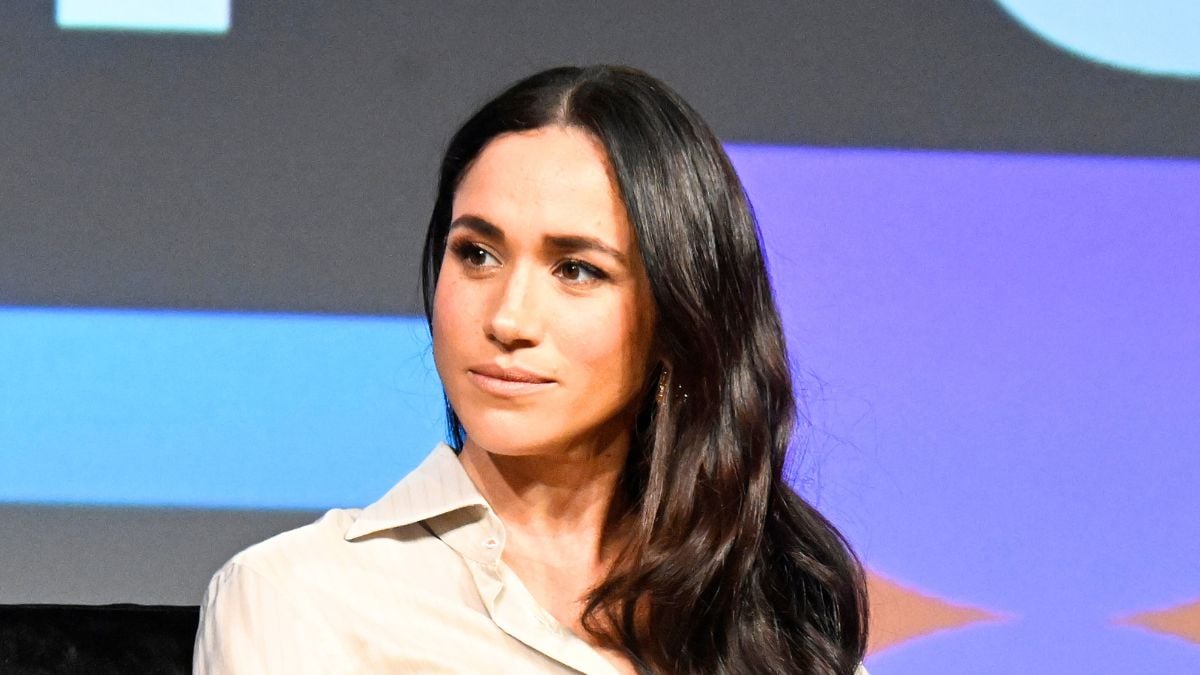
[433,126,654,455]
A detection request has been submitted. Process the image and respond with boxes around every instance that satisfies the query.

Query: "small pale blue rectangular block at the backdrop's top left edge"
[54,0,232,34]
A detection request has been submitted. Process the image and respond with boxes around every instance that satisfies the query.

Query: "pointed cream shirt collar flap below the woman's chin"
[346,443,491,540]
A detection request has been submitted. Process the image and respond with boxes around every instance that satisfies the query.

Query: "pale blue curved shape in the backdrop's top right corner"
[996,0,1200,77]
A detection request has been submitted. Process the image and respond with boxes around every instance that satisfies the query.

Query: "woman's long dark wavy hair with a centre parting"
[421,66,866,675]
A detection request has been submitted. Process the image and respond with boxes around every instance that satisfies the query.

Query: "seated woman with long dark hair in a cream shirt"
[196,66,866,674]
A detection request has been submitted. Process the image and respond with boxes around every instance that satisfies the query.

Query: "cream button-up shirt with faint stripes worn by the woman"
[193,444,873,675]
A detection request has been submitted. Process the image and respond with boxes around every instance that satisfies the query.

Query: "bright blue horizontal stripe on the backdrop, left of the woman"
[0,309,443,509]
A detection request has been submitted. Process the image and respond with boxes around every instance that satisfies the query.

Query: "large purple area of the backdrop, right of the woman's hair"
[731,147,1200,675]
